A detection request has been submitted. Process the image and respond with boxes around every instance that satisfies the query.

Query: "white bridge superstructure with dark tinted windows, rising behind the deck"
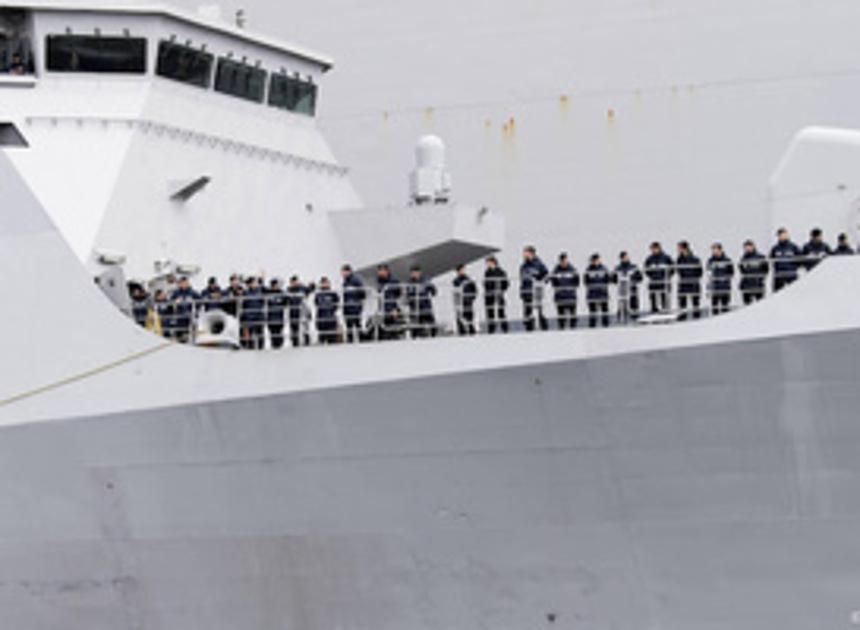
[0,4,361,277]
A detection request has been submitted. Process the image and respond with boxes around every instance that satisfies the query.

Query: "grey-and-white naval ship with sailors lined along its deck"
[0,3,860,630]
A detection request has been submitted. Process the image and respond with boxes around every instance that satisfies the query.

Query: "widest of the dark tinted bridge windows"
[47,35,146,74]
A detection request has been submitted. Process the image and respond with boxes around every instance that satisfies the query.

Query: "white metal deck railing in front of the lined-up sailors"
[132,256,832,349]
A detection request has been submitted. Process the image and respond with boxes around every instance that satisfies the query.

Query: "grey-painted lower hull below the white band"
[0,330,860,630]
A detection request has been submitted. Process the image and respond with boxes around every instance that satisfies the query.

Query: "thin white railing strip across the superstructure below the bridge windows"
[24,116,349,176]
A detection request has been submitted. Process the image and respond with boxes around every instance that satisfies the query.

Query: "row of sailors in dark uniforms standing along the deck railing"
[130,229,854,349]
